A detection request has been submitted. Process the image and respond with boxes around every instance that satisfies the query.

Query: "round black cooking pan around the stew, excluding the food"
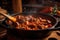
[1,13,58,38]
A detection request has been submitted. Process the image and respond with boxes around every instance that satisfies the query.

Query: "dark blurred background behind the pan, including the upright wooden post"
[0,0,60,13]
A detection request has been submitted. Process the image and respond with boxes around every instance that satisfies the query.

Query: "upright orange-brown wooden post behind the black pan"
[12,0,22,13]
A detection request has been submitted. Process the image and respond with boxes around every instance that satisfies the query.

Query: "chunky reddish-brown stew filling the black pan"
[7,15,52,30]
